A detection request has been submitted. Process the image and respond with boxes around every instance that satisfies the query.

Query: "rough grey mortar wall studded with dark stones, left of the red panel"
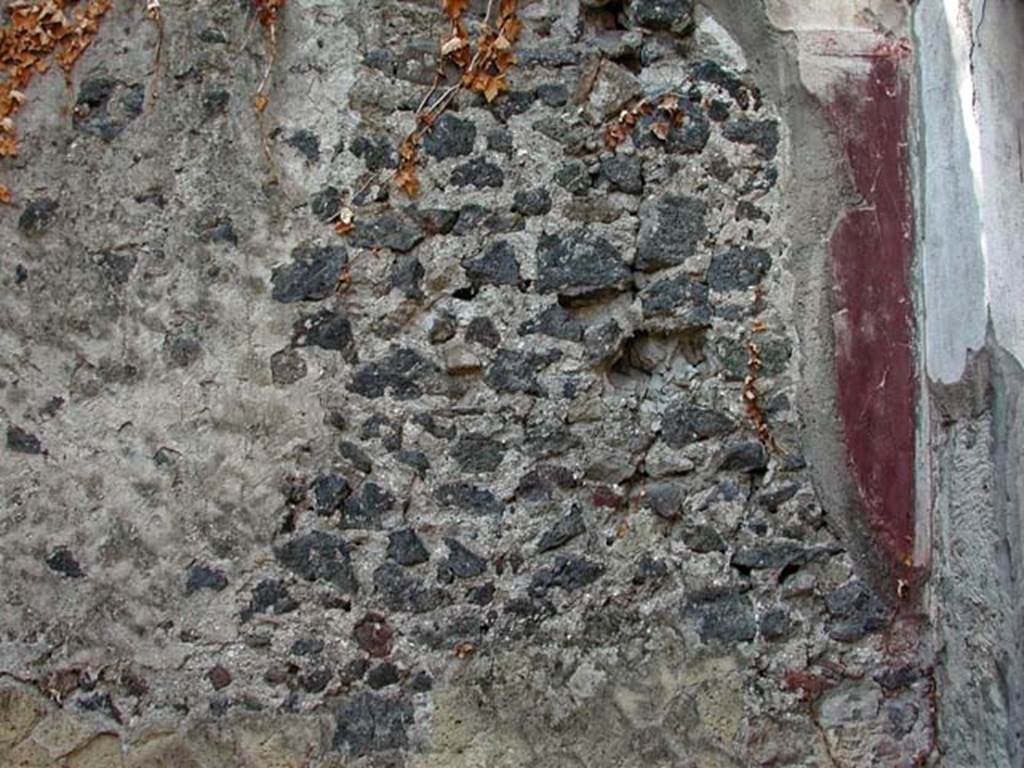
[0,0,934,767]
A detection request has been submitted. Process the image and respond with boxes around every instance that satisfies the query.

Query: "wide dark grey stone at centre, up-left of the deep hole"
[537,229,632,298]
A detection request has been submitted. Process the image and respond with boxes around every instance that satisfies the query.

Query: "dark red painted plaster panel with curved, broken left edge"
[829,49,915,566]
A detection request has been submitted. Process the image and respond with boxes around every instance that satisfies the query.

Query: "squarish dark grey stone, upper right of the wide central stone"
[636,195,708,272]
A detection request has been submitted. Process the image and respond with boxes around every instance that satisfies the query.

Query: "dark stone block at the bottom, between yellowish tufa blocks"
[332,691,414,758]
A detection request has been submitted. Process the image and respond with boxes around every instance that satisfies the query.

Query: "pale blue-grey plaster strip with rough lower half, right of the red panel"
[914,0,1024,766]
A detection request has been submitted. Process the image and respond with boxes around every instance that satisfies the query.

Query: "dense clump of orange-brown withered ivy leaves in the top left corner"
[0,0,112,203]
